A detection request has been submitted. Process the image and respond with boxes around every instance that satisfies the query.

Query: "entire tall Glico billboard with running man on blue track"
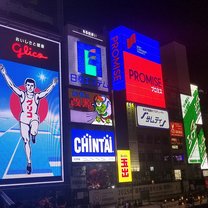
[0,25,63,186]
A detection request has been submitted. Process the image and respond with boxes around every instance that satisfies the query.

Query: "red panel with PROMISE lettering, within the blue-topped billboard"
[124,52,166,108]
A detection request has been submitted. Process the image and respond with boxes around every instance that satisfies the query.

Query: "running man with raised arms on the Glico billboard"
[0,64,58,174]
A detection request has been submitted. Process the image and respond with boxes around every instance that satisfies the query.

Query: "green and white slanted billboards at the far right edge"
[180,85,207,169]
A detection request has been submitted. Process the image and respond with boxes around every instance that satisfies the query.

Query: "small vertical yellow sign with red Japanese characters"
[117,150,132,183]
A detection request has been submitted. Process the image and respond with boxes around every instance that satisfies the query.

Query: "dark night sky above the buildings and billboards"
[64,0,208,91]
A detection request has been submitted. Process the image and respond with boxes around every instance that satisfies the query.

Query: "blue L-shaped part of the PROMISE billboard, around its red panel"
[110,26,161,90]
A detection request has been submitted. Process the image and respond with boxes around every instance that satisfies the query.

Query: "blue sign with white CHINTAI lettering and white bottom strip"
[71,129,115,162]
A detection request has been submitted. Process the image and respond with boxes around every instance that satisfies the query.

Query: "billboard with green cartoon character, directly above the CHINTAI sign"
[69,89,112,126]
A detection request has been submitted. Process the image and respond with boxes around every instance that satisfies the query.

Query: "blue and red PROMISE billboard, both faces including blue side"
[110,26,166,108]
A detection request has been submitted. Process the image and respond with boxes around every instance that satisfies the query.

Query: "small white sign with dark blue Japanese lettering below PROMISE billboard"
[137,106,169,129]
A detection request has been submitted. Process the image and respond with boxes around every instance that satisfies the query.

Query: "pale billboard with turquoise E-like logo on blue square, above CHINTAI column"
[68,35,109,92]
